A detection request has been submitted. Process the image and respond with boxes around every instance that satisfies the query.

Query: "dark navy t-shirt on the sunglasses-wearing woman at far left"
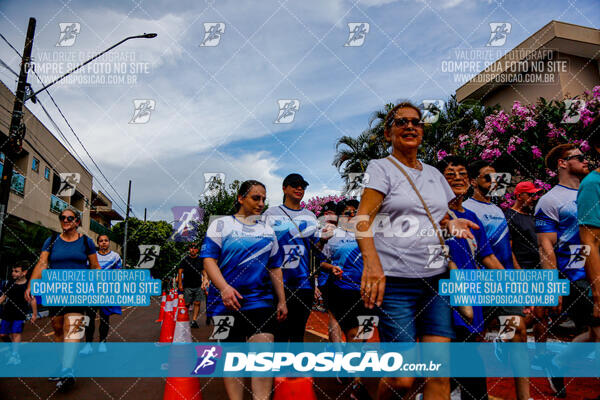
[42,235,96,269]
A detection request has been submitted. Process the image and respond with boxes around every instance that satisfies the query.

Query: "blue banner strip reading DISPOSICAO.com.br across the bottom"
[0,343,600,378]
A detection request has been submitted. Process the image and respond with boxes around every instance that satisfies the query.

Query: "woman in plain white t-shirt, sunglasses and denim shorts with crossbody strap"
[357,103,477,398]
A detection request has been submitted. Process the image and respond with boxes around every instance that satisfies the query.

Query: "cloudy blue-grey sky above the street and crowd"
[0,0,600,221]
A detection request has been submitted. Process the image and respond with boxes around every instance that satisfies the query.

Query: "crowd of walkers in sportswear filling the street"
[0,103,600,400]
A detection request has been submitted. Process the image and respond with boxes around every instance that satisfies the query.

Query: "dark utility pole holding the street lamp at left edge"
[0,18,35,274]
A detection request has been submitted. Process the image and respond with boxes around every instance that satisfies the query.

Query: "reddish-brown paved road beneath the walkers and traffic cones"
[0,298,600,400]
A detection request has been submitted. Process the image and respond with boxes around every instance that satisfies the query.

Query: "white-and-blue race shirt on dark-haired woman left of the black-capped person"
[200,216,283,316]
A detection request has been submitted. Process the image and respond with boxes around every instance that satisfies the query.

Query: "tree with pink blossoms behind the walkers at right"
[426,86,600,206]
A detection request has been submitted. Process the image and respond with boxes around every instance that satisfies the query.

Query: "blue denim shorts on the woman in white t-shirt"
[379,273,455,342]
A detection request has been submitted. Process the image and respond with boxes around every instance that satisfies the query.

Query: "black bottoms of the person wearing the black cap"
[275,288,315,342]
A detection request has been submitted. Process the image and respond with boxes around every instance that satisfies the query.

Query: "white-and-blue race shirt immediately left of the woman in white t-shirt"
[323,228,363,290]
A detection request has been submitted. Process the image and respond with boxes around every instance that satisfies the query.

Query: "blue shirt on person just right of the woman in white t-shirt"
[446,209,494,332]
